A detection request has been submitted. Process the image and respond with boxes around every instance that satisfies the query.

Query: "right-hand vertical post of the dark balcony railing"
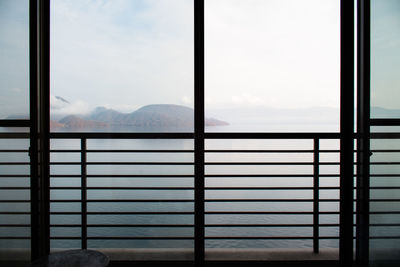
[313,138,319,253]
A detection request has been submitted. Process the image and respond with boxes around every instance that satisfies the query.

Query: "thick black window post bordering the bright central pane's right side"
[339,0,354,266]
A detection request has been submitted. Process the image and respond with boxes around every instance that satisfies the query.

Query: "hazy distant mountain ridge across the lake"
[52,104,229,130]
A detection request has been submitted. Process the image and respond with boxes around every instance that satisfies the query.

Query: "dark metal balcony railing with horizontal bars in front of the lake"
[0,133,400,264]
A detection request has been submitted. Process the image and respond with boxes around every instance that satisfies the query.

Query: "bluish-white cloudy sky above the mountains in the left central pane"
[51,0,193,109]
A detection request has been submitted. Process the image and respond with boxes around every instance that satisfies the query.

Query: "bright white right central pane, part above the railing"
[205,0,340,132]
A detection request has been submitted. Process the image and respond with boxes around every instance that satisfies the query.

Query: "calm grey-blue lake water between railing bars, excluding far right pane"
[0,124,339,248]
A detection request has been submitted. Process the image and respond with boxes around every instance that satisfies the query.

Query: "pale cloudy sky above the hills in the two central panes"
[51,0,340,110]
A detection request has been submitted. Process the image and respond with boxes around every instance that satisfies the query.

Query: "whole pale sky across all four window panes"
[0,0,400,117]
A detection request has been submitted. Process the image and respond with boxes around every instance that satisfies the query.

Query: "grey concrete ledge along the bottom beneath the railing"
[0,248,339,261]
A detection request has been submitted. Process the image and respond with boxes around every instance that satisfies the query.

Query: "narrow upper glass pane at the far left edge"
[0,0,29,119]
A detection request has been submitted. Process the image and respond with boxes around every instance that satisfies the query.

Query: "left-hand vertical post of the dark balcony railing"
[81,137,87,249]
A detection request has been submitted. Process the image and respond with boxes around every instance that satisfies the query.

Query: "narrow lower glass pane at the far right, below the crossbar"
[370,127,400,266]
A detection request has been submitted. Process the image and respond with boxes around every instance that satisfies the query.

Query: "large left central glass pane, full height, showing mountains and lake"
[50,0,194,261]
